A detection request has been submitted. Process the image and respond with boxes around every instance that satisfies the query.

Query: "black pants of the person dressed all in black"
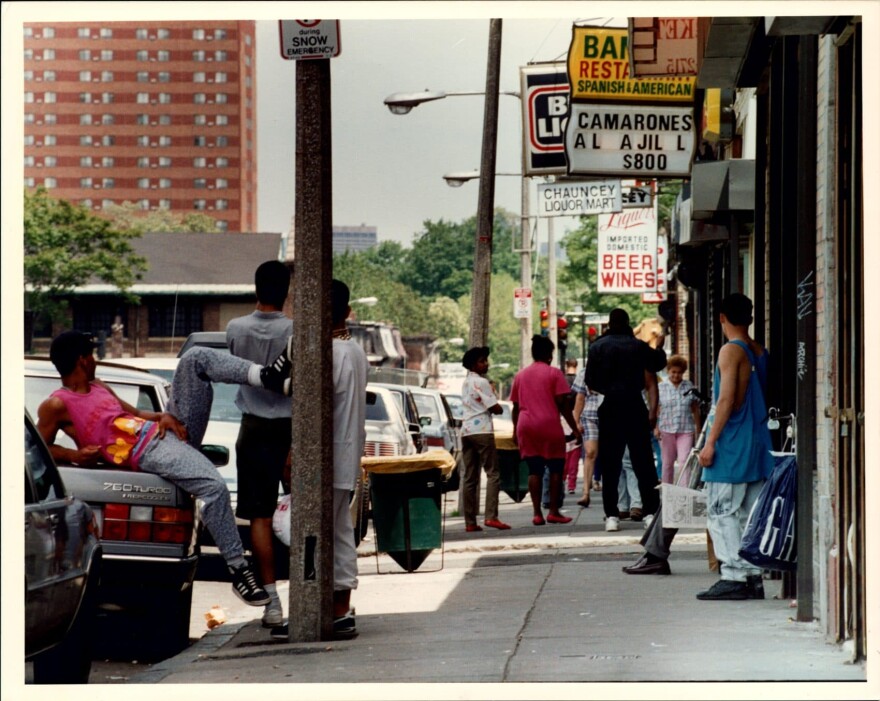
[596,395,660,516]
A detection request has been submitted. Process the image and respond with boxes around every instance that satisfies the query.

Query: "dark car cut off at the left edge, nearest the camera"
[24,410,102,684]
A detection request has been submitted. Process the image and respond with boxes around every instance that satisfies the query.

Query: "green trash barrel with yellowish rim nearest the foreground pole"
[370,467,443,572]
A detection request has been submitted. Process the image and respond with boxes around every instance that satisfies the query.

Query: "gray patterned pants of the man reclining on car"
[140,346,253,564]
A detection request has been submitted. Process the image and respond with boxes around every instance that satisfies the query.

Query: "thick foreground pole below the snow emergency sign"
[288,59,333,642]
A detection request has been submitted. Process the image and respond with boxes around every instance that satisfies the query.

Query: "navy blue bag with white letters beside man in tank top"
[739,455,797,571]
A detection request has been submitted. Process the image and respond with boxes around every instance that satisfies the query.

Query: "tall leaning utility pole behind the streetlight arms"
[470,19,501,347]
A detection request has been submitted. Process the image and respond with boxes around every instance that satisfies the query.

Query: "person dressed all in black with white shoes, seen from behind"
[586,308,666,531]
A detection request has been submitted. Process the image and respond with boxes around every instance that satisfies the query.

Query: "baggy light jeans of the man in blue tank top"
[703,473,764,582]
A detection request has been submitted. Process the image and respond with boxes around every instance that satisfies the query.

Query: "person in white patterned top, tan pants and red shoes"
[461,346,510,533]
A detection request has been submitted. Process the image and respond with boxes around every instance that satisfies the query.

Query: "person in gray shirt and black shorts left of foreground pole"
[226,260,292,628]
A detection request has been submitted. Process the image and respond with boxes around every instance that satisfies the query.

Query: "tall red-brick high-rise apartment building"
[24,20,257,232]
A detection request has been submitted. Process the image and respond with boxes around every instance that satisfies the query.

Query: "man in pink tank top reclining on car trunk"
[37,331,290,606]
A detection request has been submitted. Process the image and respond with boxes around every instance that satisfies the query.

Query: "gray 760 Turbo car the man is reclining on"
[25,357,228,659]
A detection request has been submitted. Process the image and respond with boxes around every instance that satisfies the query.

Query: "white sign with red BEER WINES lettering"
[596,202,657,294]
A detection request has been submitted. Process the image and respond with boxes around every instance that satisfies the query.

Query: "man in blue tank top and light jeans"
[697,293,773,600]
